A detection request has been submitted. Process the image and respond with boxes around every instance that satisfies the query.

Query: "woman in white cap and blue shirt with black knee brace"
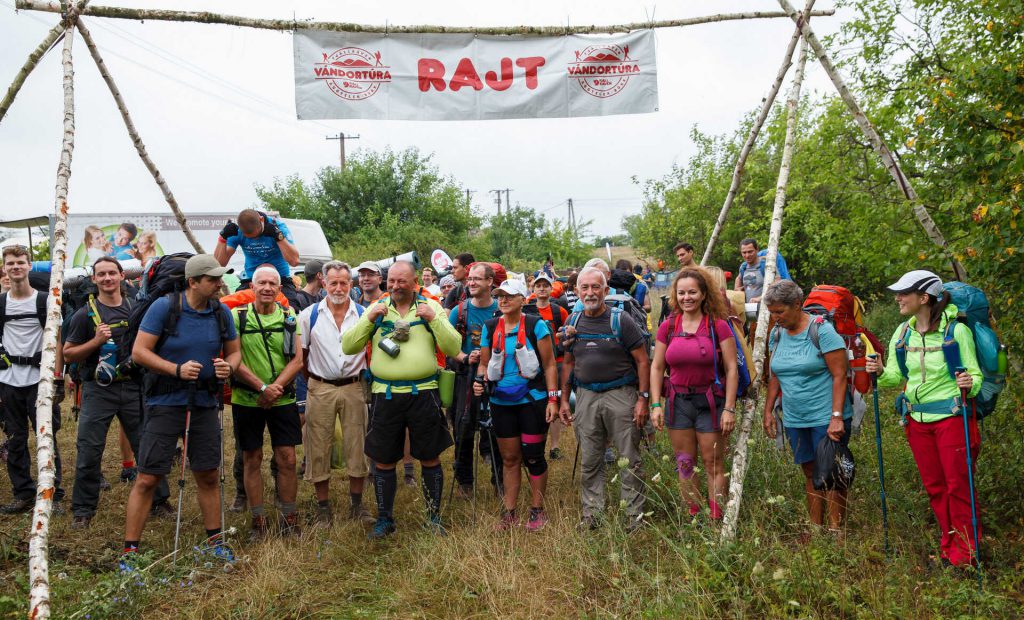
[473,280,561,532]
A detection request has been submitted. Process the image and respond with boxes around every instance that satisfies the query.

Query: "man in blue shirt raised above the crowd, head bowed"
[213,209,299,282]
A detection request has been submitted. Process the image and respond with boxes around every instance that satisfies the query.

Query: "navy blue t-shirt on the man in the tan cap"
[138,293,239,407]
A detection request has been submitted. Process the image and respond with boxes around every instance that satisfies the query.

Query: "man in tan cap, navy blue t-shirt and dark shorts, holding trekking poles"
[124,254,242,565]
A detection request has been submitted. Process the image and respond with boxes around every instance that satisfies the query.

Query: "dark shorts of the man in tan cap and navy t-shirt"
[137,405,221,476]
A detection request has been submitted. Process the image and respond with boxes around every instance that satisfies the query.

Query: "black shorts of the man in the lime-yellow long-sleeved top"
[364,389,455,464]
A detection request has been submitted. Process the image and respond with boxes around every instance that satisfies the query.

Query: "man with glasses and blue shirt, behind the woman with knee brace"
[449,262,502,498]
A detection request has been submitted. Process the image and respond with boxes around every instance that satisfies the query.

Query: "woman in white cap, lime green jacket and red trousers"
[866,270,982,567]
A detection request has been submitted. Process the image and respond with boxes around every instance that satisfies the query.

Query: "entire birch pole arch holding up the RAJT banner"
[0,0,962,618]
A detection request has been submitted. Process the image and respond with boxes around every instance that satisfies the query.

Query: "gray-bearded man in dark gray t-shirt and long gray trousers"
[559,267,650,532]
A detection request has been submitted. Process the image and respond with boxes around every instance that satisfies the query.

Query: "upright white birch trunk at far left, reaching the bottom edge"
[29,19,75,618]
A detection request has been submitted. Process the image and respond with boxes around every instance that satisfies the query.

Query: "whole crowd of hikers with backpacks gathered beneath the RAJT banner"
[0,209,1006,570]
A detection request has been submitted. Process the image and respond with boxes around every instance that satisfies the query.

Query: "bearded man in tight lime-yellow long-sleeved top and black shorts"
[341,260,460,540]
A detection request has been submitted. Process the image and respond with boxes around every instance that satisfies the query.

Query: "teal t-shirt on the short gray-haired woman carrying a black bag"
[768,319,853,428]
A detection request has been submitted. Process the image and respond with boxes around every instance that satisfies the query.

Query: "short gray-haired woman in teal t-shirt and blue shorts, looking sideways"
[762,280,853,536]
